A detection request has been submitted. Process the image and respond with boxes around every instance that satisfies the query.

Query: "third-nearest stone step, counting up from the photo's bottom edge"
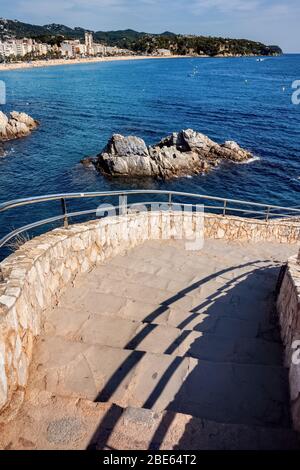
[45,300,280,343]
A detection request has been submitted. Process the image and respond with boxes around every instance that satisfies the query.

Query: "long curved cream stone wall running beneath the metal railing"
[0,211,300,421]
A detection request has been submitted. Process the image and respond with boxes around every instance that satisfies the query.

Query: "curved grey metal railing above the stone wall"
[0,190,300,252]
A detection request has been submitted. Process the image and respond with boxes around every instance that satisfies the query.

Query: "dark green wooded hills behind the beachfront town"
[0,19,282,56]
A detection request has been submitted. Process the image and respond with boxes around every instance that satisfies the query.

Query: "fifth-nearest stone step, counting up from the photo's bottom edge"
[89,255,280,301]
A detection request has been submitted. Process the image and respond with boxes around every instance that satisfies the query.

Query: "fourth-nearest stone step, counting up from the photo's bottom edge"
[60,274,274,325]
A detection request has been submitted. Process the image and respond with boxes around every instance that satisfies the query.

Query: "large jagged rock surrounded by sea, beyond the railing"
[94,129,253,179]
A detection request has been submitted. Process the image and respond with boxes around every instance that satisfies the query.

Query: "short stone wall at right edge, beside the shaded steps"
[277,252,300,432]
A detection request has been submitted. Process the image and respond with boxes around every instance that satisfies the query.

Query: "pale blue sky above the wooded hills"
[0,0,300,52]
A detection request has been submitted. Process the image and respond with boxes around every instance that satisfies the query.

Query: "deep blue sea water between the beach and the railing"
[0,55,300,253]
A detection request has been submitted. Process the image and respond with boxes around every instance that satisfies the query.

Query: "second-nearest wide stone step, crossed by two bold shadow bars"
[31,337,290,427]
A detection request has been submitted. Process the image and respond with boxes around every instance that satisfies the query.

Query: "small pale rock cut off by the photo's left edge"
[0,111,39,142]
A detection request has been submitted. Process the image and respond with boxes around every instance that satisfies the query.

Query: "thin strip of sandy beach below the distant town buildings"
[0,55,195,71]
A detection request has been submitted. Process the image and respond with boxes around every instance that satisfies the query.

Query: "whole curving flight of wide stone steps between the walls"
[3,241,299,450]
